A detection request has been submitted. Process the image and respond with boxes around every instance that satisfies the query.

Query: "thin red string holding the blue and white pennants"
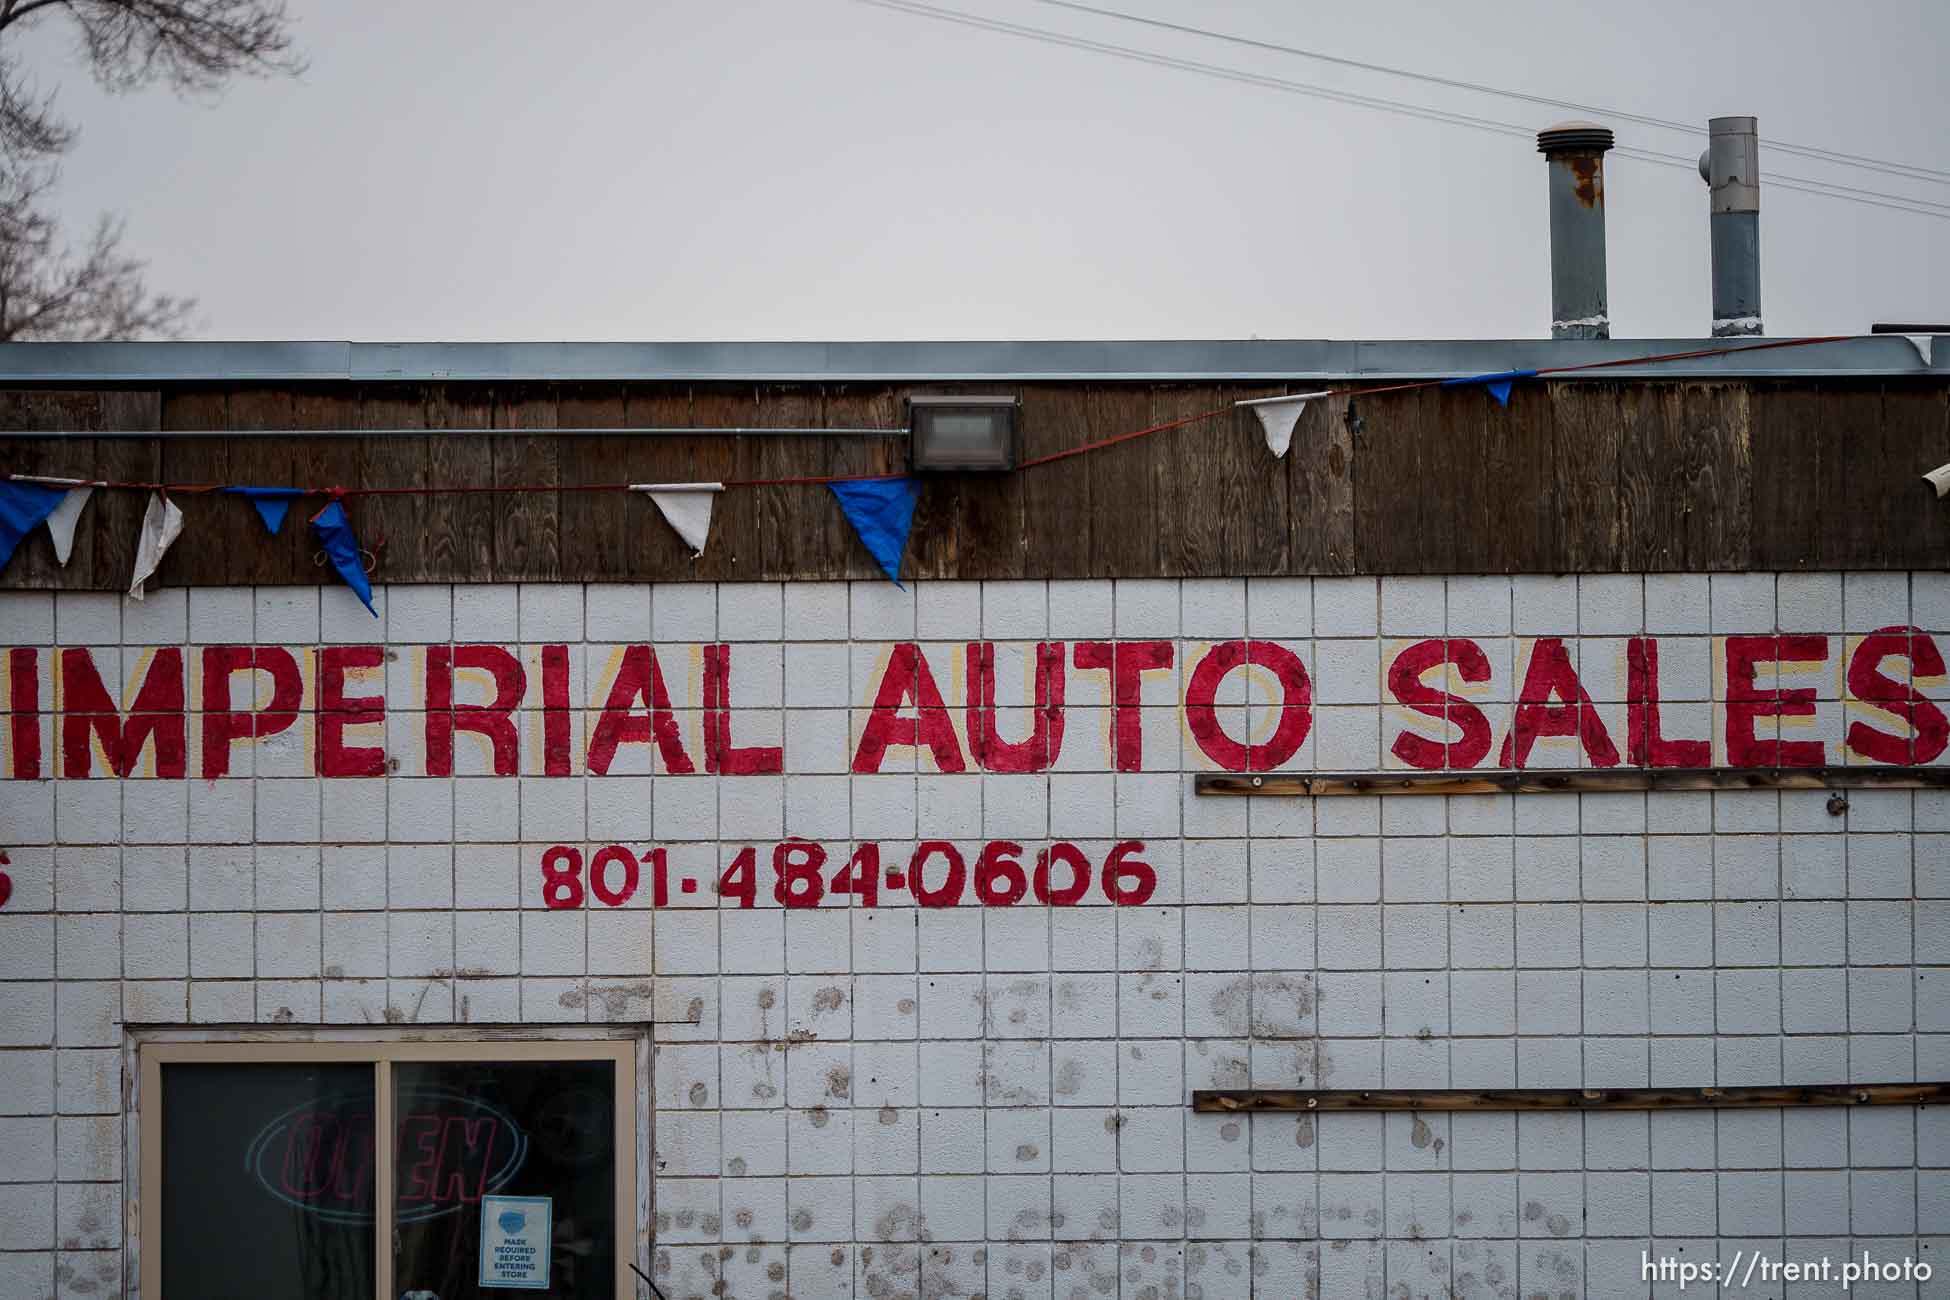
[6,333,1858,499]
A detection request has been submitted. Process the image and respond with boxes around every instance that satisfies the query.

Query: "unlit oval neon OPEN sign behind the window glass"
[244,1088,528,1224]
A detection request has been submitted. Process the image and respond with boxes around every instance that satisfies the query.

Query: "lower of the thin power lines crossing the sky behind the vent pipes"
[860,0,1950,220]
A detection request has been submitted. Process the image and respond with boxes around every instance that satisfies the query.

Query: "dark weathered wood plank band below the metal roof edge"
[0,380,1950,589]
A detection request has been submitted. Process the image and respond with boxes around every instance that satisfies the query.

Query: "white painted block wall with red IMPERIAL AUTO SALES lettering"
[0,573,1950,1300]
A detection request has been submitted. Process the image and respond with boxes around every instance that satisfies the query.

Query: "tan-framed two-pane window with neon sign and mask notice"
[138,1037,640,1300]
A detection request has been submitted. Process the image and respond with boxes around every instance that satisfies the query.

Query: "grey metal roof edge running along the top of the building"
[0,335,1950,384]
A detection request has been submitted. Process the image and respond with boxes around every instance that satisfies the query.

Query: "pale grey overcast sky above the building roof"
[23,0,1950,339]
